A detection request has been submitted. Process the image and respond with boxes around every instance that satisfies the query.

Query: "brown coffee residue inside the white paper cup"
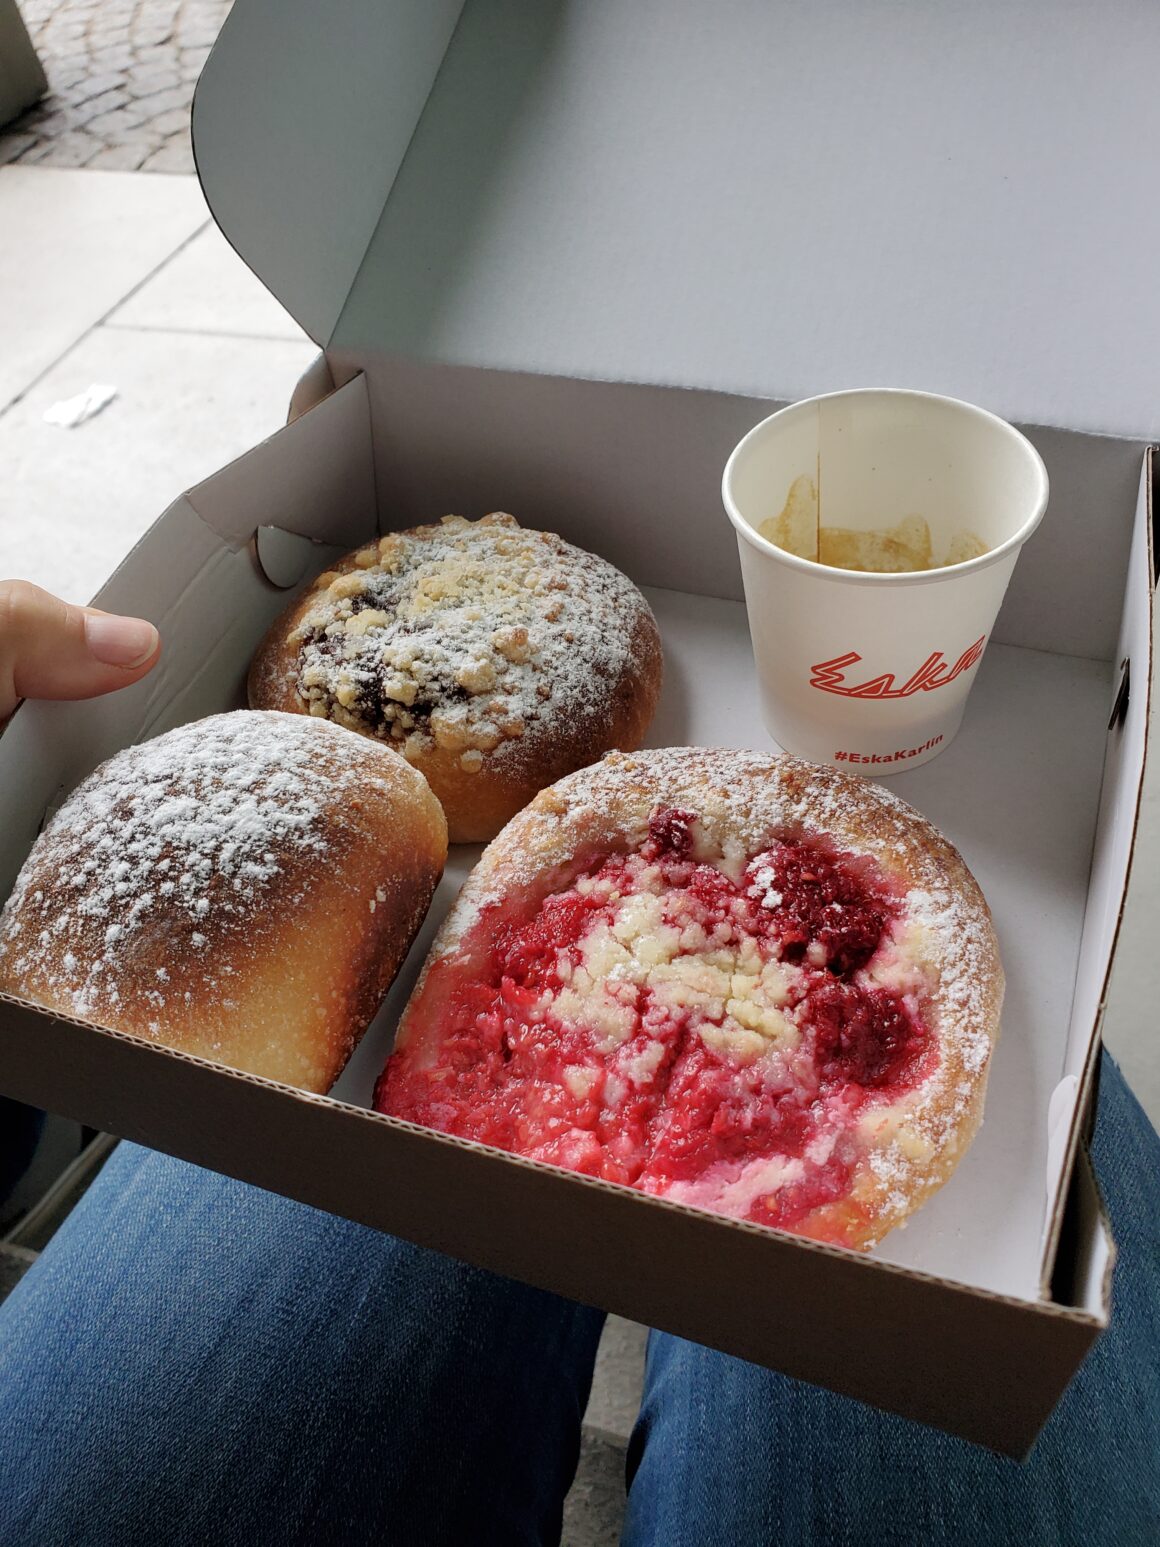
[758,475,987,574]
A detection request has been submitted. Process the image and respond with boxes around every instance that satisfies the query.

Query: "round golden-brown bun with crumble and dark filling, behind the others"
[249,514,662,843]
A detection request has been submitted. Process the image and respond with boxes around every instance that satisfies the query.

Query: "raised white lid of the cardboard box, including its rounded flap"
[193,0,1160,438]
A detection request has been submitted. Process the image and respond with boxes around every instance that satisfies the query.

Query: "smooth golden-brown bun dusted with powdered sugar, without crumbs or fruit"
[0,710,447,1092]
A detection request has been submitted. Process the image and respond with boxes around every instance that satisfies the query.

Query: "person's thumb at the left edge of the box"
[0,580,161,726]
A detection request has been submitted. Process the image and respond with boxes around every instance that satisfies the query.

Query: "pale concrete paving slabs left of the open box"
[0,167,317,602]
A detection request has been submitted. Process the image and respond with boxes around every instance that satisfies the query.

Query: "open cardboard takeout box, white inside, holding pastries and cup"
[0,0,1160,1454]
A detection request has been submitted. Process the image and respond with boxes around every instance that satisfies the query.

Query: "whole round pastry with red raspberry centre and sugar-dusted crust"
[376,747,1004,1248]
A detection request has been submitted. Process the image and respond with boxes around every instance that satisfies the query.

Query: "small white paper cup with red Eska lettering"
[722,388,1047,775]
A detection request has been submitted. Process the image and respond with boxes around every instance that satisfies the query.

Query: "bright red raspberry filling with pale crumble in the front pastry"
[376,808,936,1233]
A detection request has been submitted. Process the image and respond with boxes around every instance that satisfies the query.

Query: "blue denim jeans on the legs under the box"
[0,1060,1160,1547]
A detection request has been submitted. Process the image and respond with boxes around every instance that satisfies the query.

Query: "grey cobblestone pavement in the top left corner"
[0,0,232,172]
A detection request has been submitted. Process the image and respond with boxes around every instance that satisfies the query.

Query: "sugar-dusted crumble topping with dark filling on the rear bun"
[281,514,650,772]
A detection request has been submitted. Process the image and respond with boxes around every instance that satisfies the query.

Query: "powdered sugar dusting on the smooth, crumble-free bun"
[0,712,415,1018]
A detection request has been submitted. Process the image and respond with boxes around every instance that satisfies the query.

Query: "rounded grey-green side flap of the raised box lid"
[193,0,462,343]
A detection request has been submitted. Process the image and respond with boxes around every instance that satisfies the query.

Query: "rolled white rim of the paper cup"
[721,387,1049,586]
